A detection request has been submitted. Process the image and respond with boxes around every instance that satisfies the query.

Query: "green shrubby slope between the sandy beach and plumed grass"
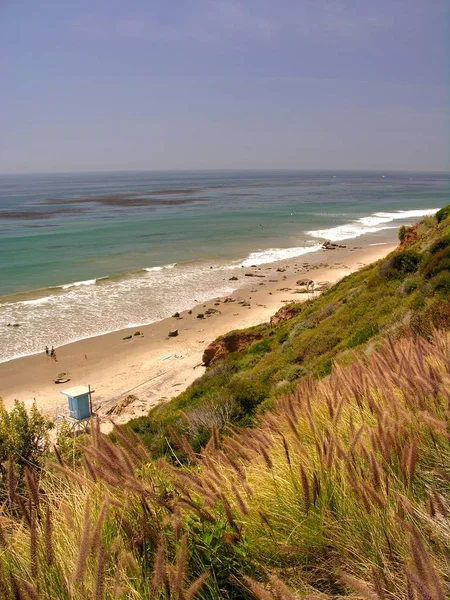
[125,206,450,456]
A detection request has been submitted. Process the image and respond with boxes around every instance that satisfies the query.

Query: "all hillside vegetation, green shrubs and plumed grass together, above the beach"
[0,207,450,600]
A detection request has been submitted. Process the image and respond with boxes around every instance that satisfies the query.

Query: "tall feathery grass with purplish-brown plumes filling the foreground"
[0,332,450,600]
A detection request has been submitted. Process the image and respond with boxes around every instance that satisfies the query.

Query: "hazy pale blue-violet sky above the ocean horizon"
[0,0,450,173]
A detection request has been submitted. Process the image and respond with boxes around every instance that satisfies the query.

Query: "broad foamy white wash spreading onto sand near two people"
[0,265,239,364]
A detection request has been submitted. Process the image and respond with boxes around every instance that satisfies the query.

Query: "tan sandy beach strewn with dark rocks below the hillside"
[0,240,395,429]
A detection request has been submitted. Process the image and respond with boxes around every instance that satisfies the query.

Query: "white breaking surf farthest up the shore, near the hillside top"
[305,208,439,242]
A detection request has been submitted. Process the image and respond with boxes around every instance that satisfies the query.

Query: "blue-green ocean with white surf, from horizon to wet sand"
[0,171,450,362]
